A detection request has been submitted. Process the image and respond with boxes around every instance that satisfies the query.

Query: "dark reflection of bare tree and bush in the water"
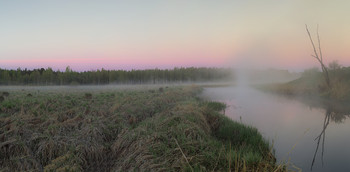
[311,102,350,170]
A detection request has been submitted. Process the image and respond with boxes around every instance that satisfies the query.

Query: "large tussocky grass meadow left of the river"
[0,86,284,171]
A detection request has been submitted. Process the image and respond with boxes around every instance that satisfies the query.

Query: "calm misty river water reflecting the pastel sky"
[203,87,350,172]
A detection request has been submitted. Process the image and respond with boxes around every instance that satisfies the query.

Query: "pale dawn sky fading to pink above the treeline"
[0,0,350,71]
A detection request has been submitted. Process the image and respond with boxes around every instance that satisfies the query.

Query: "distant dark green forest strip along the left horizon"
[0,66,231,85]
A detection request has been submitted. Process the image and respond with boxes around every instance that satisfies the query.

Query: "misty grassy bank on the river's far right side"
[259,67,350,101]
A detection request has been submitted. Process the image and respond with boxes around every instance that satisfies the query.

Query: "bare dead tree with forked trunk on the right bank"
[305,25,331,89]
